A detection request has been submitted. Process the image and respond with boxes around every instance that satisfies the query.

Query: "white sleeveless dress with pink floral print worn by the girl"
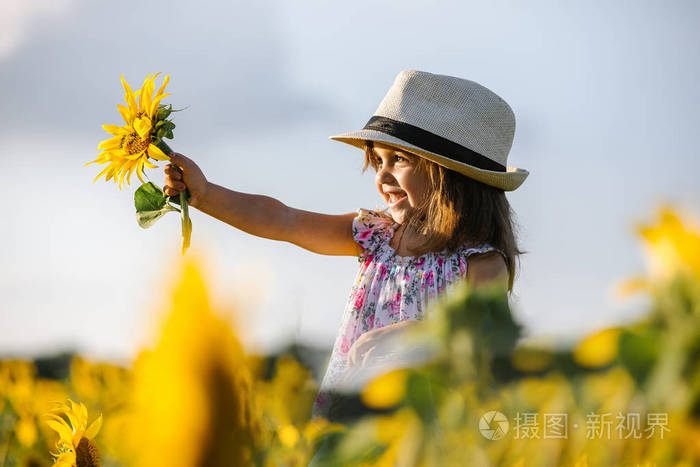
[312,208,503,418]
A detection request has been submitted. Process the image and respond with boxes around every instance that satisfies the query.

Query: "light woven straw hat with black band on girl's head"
[329,70,529,191]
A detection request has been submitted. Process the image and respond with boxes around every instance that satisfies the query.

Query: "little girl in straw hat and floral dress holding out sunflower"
[164,70,528,418]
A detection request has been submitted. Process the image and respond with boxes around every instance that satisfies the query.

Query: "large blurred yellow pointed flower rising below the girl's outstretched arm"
[127,259,261,467]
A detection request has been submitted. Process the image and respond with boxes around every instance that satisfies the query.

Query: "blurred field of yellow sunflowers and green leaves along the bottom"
[0,207,700,467]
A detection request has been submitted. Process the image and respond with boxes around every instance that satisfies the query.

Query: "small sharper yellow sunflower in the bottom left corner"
[46,399,102,467]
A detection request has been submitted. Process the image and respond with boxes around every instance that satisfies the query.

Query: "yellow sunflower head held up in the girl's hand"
[85,73,170,190]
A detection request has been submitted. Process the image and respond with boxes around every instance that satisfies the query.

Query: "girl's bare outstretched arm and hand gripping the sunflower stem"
[164,153,360,256]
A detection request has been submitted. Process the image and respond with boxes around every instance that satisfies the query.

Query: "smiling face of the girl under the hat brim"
[374,142,430,224]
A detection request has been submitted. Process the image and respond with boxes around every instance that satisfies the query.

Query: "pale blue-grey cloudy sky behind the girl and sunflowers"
[0,0,700,361]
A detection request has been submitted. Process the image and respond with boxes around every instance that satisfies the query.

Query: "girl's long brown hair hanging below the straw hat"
[362,140,526,292]
